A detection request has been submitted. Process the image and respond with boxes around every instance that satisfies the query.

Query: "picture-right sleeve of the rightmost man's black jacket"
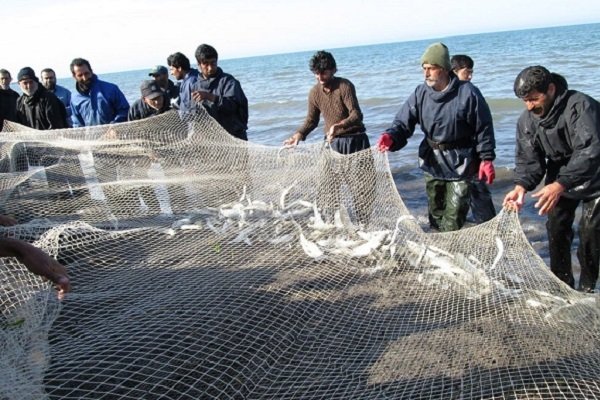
[556,97,600,190]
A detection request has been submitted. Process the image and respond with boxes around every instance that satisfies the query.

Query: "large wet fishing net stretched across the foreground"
[0,112,600,400]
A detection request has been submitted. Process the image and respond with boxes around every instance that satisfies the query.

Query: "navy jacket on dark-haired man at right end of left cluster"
[193,68,248,140]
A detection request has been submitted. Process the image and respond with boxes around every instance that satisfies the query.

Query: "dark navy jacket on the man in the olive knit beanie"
[386,73,496,181]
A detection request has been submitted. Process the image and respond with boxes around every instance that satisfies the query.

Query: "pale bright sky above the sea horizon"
[0,0,600,80]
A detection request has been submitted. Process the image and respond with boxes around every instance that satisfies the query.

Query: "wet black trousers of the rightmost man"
[546,197,600,291]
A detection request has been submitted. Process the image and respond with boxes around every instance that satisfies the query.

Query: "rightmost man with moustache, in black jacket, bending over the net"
[504,66,600,292]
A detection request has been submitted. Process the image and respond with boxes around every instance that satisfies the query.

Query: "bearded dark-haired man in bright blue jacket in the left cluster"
[71,58,129,128]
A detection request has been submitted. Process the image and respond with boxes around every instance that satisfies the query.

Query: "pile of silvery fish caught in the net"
[158,185,600,321]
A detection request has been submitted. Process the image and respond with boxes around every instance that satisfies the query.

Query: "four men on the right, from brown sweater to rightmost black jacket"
[284,43,600,292]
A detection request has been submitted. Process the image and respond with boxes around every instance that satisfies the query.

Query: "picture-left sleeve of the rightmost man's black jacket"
[514,113,546,191]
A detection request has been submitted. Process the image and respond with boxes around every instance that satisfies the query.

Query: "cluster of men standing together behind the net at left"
[0,44,248,140]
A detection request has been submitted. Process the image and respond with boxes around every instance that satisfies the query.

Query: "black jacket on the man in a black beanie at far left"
[17,83,68,130]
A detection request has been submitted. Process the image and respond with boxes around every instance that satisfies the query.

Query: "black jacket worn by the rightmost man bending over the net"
[515,87,600,200]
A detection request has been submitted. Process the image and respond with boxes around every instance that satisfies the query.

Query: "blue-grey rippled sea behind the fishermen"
[45,23,600,170]
